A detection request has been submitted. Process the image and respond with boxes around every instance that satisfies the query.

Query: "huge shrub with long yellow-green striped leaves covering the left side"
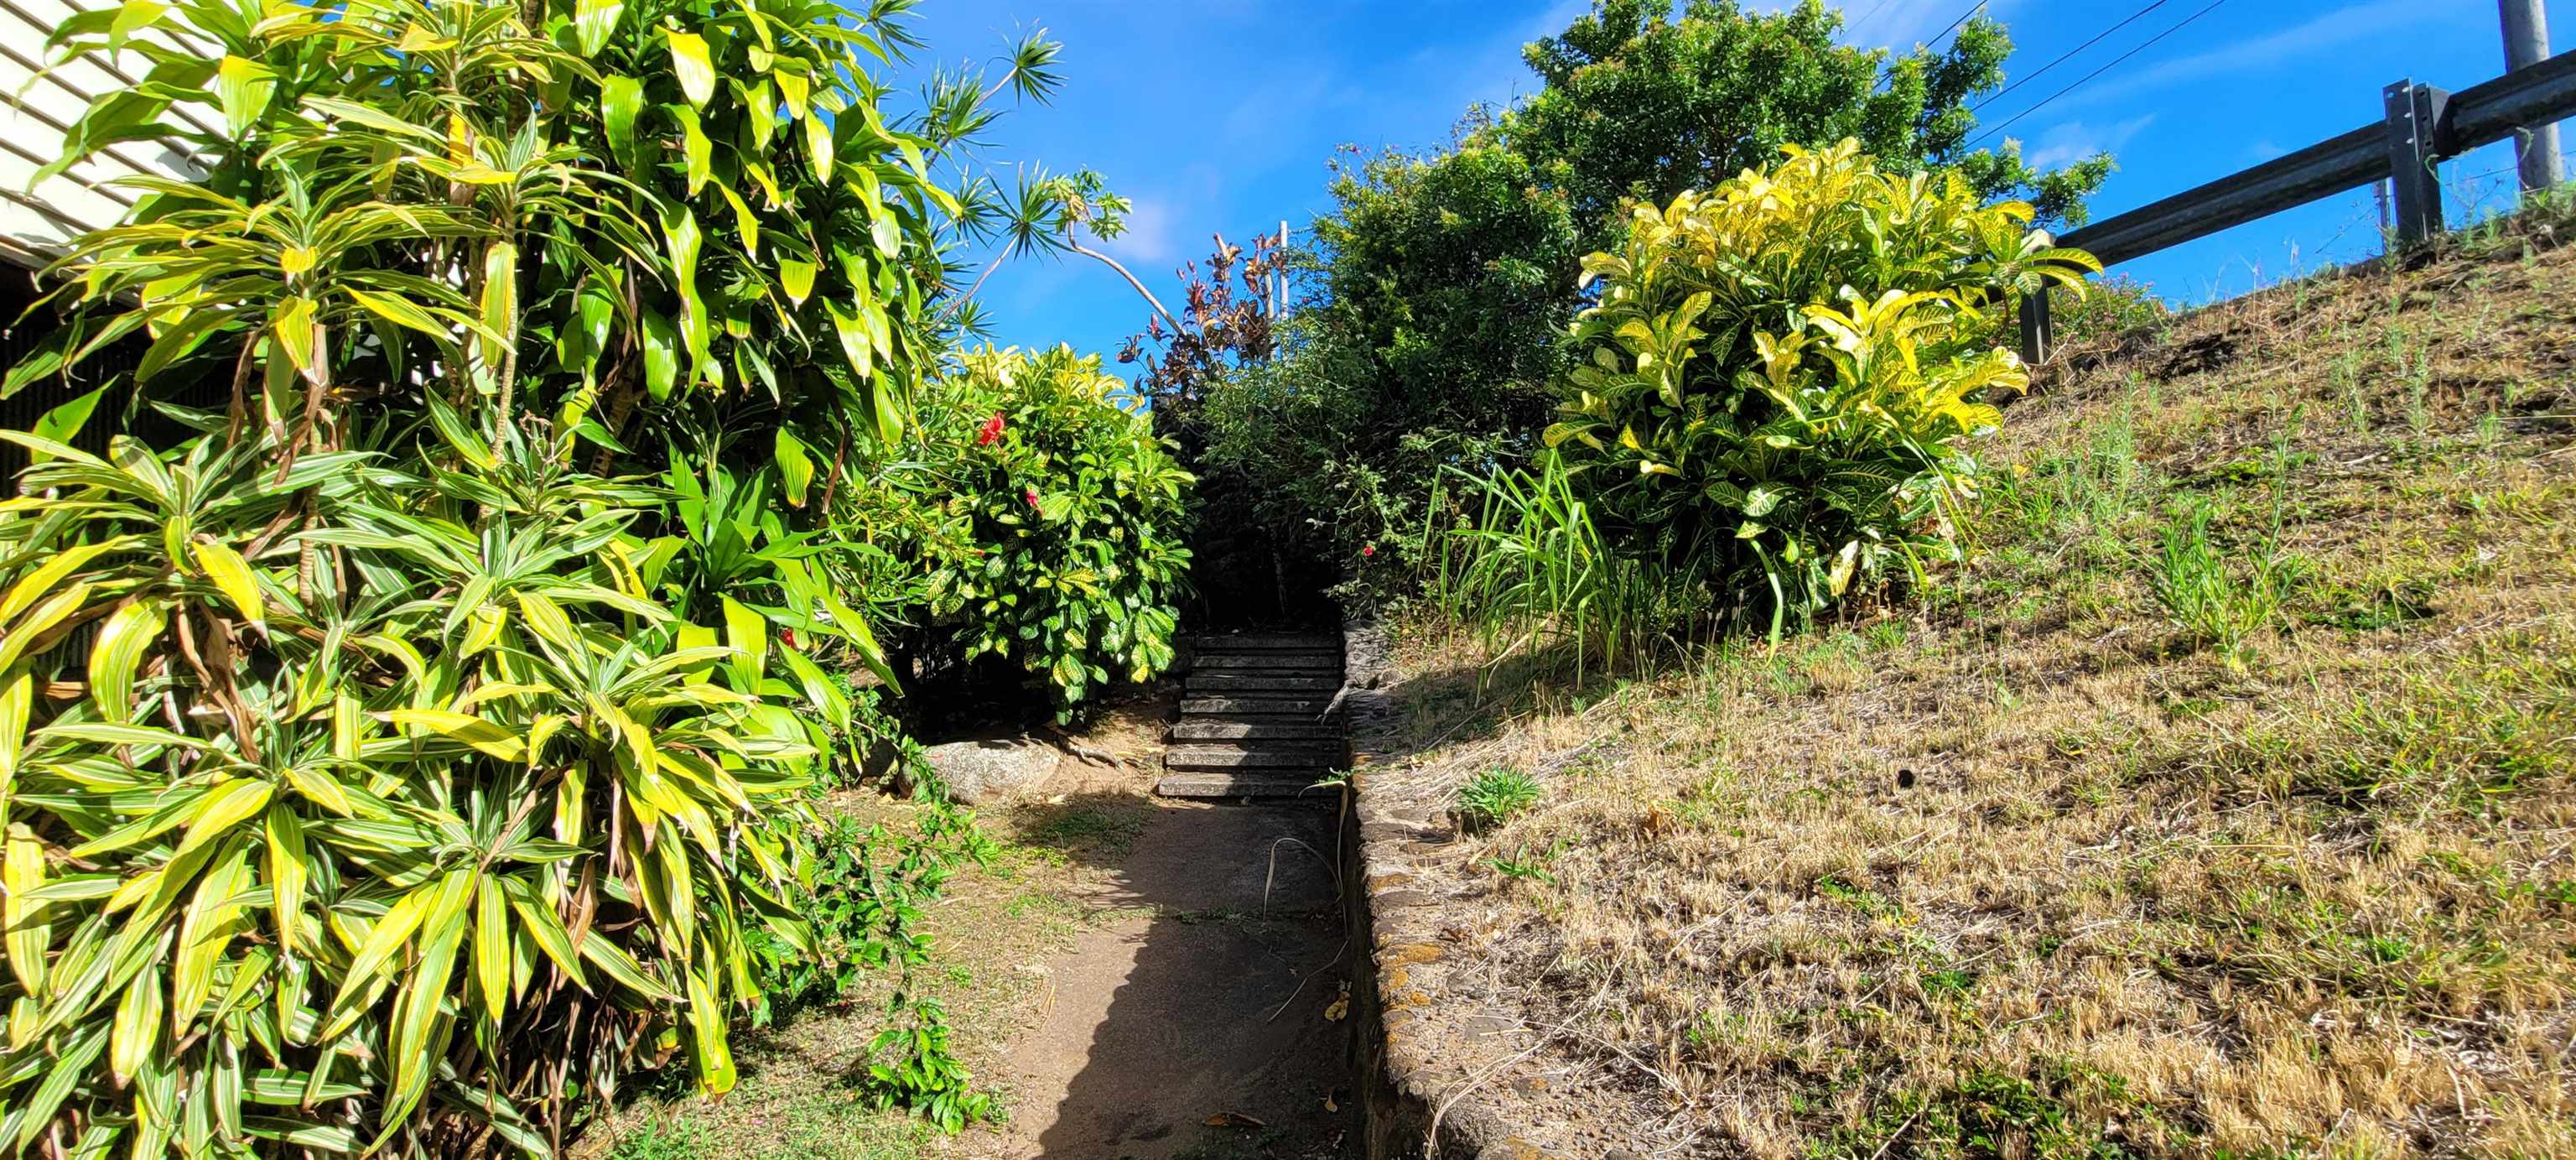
[0,0,1025,1155]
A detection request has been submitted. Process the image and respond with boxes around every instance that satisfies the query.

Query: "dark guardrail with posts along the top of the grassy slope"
[2023,51,2576,363]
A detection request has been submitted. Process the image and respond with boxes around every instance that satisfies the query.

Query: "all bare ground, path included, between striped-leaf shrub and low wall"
[574,683,1360,1160]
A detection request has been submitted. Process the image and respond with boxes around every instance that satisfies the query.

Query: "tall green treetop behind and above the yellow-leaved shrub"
[1492,0,2110,238]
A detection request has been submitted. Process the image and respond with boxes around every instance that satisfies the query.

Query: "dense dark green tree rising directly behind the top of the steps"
[1206,144,1581,598]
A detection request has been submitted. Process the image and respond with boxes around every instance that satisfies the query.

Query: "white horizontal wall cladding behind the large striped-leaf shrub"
[0,0,205,266]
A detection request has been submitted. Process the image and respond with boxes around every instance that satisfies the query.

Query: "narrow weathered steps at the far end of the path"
[1154,632,1350,802]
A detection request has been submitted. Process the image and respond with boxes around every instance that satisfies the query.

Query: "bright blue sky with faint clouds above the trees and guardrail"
[896,0,2545,371]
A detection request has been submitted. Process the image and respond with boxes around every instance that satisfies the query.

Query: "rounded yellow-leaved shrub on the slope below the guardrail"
[1545,142,2097,644]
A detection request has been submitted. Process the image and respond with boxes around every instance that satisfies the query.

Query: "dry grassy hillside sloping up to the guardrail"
[1399,212,2576,1157]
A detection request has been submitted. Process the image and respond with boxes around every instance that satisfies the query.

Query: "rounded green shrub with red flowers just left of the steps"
[909,348,1192,709]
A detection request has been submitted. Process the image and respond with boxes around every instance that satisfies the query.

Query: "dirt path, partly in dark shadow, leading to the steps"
[995,768,1358,1160]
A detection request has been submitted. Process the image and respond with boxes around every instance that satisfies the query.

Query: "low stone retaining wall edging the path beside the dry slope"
[1343,622,1555,1160]
